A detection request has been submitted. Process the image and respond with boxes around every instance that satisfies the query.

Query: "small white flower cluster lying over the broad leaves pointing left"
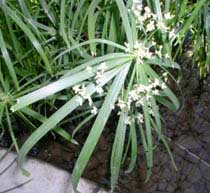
[72,84,98,115]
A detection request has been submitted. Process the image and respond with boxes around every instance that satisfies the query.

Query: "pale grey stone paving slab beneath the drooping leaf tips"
[0,149,108,193]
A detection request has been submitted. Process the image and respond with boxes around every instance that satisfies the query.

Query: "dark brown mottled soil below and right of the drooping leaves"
[0,63,210,193]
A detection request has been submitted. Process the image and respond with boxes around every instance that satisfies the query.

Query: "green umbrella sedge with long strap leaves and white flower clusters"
[0,0,208,191]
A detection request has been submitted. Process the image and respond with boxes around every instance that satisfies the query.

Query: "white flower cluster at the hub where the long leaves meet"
[125,41,153,64]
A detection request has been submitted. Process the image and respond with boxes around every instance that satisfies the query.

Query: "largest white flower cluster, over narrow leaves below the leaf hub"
[117,79,166,124]
